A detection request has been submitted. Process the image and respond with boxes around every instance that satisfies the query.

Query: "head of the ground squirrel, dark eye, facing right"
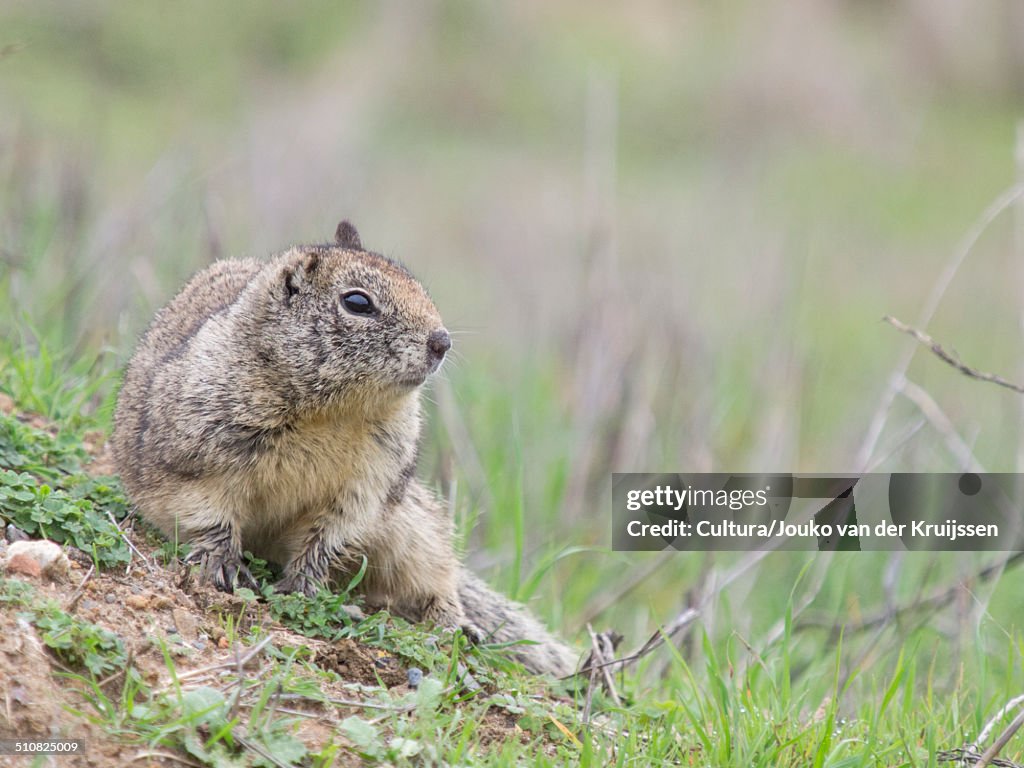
[254,221,452,399]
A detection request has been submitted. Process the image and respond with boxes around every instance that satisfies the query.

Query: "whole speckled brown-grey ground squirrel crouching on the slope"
[111,221,575,676]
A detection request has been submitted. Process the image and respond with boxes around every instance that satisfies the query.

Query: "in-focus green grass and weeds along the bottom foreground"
[9,548,1022,768]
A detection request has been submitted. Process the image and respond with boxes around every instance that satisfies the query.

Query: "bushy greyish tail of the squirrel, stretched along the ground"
[459,568,579,677]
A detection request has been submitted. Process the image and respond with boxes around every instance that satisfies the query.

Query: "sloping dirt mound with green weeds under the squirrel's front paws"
[0,405,569,766]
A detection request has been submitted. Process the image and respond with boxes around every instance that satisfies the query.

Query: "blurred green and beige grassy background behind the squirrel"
[0,0,1024,704]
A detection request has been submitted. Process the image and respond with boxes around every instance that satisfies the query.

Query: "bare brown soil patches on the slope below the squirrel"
[0,401,544,768]
